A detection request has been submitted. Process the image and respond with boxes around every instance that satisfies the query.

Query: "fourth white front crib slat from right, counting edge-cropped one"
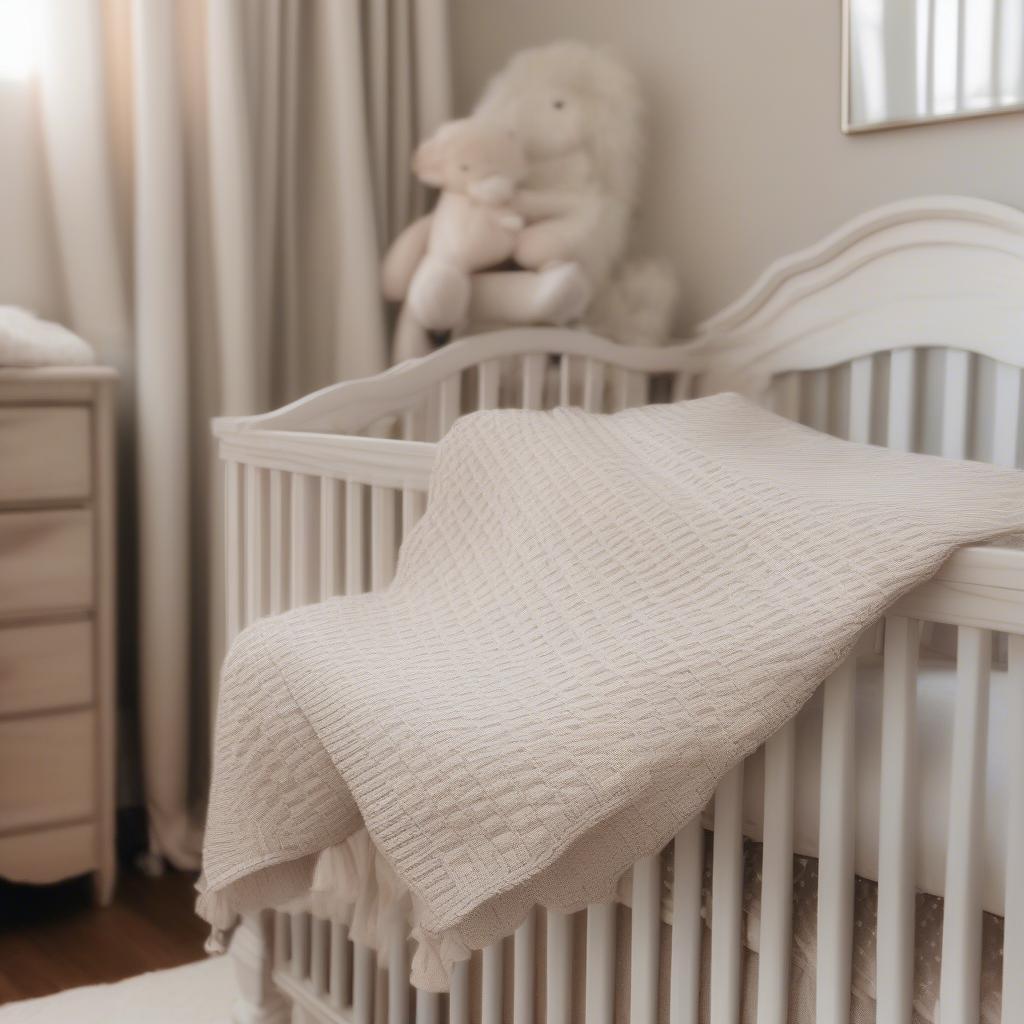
[815,658,855,1024]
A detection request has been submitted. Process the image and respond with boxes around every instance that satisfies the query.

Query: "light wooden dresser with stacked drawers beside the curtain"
[0,367,117,904]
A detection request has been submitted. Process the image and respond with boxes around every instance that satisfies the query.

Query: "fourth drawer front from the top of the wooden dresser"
[0,711,96,833]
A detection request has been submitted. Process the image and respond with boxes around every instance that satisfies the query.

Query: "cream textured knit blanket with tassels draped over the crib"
[200,395,1024,989]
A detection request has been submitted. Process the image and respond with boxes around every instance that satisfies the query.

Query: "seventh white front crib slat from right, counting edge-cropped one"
[669,815,703,1024]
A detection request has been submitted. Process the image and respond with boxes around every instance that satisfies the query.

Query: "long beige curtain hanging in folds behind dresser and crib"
[20,0,451,866]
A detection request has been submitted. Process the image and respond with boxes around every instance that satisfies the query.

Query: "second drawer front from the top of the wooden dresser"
[0,509,92,615]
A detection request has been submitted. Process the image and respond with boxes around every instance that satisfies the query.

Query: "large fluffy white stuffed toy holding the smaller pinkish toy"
[389,42,677,359]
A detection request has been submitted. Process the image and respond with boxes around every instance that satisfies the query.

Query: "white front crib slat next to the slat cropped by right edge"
[939,626,992,1024]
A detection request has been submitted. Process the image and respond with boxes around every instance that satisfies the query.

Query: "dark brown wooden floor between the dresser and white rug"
[0,871,207,1004]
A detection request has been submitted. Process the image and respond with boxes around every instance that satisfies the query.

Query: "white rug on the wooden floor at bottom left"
[0,956,236,1024]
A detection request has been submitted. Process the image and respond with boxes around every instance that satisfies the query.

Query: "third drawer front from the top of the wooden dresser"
[0,620,93,716]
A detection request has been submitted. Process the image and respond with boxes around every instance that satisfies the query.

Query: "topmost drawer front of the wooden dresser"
[0,406,92,502]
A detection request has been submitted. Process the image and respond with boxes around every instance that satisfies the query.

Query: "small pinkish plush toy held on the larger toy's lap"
[382,117,589,331]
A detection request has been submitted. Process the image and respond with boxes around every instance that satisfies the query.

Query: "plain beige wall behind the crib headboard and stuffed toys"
[453,0,1024,330]
